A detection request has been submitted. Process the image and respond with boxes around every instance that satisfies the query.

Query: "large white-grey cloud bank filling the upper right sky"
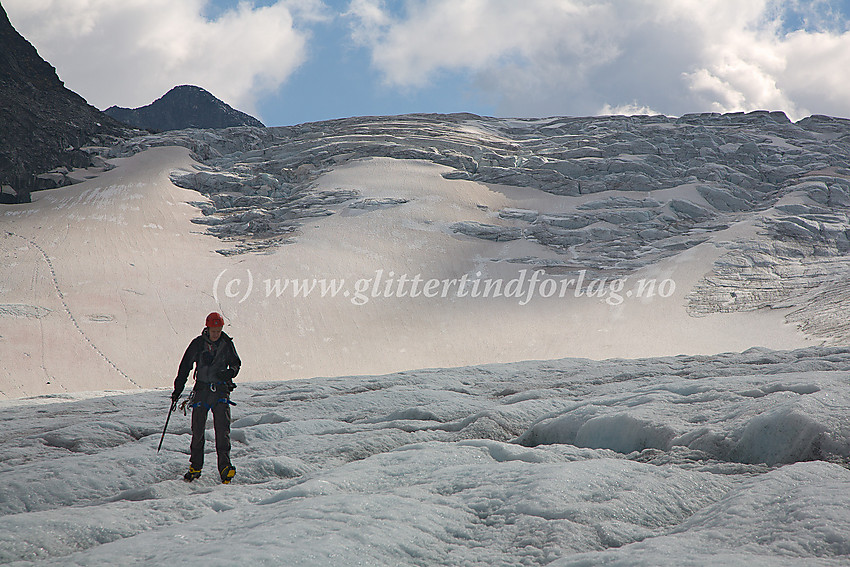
[342,0,850,118]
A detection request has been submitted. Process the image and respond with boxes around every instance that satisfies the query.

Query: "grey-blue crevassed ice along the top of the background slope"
[111,111,850,344]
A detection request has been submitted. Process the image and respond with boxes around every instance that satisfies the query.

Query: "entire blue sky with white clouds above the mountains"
[0,0,850,126]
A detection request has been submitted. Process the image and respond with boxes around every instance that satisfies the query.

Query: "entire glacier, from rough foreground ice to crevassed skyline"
[0,108,850,566]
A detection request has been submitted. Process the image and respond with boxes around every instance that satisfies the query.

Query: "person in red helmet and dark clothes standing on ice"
[171,313,242,484]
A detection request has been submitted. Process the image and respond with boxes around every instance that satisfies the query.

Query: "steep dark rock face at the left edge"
[0,1,133,203]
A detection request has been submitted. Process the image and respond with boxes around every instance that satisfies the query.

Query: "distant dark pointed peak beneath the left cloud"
[104,85,263,132]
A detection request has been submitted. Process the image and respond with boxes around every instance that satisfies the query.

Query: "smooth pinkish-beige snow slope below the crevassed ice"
[0,140,810,397]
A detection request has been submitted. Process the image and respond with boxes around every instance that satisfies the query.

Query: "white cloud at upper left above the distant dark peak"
[3,0,324,116]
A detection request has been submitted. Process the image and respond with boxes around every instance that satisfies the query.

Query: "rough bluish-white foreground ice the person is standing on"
[0,348,850,566]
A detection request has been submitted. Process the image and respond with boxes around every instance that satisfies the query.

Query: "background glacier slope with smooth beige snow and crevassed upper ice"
[6,108,850,397]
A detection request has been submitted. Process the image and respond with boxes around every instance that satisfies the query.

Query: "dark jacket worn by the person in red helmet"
[174,328,242,393]
